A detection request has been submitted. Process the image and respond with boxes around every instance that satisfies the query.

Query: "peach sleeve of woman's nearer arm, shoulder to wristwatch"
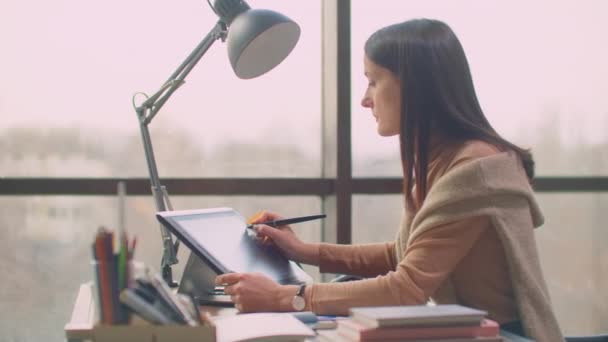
[306,216,491,315]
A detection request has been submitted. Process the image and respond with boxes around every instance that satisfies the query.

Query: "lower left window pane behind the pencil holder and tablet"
[0,196,321,341]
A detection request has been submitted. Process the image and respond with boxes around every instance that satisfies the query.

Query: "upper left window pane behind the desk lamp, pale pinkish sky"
[0,0,321,177]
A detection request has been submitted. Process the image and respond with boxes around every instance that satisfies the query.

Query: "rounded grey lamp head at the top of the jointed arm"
[214,0,300,79]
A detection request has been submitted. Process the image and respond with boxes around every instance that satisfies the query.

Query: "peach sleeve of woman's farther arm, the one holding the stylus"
[319,242,396,277]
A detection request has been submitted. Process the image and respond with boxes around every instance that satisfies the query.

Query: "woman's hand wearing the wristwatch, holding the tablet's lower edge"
[215,273,298,312]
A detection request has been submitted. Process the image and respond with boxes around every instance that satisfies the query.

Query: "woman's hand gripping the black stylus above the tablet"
[250,211,319,265]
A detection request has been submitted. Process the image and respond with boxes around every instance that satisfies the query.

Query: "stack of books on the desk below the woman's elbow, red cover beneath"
[319,305,502,342]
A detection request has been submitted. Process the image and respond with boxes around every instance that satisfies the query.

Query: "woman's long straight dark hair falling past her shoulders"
[365,19,534,208]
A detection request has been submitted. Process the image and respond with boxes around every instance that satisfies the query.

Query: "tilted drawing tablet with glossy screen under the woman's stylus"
[156,208,312,290]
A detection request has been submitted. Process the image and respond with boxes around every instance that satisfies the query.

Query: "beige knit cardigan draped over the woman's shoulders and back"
[395,152,563,342]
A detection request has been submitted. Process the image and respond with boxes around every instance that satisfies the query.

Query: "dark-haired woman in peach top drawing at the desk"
[216,19,562,341]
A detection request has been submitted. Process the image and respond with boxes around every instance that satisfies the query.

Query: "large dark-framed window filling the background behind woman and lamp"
[0,0,608,341]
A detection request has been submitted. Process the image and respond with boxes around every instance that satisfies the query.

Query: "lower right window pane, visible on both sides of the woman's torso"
[353,194,608,335]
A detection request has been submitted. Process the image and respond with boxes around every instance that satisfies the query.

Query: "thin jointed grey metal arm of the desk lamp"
[134,20,227,286]
